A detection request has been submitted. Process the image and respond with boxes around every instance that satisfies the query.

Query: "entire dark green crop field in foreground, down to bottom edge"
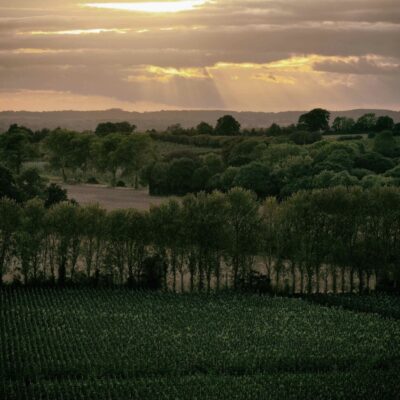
[0,288,400,400]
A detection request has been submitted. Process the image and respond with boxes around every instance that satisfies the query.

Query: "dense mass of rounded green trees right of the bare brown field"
[142,131,400,198]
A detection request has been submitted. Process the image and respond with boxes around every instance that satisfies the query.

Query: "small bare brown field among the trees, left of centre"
[63,185,168,211]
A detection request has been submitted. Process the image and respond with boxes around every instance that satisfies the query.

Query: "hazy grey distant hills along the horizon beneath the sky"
[0,109,400,132]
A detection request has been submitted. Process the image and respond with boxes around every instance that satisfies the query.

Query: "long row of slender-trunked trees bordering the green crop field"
[0,187,400,293]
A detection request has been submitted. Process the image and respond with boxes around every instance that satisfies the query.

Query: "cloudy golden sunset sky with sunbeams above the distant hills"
[0,0,400,111]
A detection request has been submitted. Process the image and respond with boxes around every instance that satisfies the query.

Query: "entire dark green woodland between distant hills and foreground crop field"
[0,109,400,293]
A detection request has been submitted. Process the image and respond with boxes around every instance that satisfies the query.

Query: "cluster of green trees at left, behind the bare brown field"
[0,123,155,186]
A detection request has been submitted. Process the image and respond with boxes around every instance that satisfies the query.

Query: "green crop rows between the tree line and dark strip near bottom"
[0,289,400,381]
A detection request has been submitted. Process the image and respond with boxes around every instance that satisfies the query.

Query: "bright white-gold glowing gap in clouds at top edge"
[83,0,207,13]
